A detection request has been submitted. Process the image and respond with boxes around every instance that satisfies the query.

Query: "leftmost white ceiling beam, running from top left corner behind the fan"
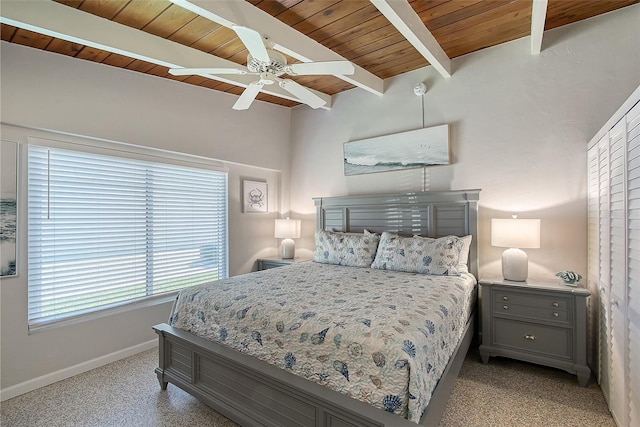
[0,1,331,108]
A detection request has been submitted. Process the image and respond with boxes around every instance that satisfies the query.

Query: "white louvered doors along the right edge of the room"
[587,91,640,427]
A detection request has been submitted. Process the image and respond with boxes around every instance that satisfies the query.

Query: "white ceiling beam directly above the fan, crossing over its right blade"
[170,0,384,95]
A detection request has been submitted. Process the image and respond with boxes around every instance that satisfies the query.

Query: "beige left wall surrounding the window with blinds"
[0,42,291,398]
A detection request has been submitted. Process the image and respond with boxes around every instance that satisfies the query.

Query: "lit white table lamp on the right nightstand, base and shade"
[491,215,540,282]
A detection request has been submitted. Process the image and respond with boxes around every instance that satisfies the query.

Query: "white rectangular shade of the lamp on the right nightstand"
[491,218,540,249]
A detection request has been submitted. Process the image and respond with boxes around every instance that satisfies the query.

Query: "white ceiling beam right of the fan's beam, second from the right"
[371,0,451,77]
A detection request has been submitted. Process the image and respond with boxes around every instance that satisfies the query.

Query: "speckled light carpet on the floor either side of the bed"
[0,349,615,427]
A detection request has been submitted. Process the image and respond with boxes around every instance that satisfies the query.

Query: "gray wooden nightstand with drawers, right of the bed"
[479,279,591,386]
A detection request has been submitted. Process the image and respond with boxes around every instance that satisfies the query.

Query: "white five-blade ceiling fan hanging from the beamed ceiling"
[169,25,355,110]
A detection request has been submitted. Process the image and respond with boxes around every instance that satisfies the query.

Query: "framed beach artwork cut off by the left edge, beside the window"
[0,141,18,277]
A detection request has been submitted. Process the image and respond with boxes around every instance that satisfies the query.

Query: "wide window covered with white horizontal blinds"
[28,144,228,328]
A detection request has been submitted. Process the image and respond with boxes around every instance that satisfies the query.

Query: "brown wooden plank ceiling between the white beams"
[0,0,640,107]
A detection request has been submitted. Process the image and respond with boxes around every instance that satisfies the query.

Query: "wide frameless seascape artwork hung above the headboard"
[344,125,450,175]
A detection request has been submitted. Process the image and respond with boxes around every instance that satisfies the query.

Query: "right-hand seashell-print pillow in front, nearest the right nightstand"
[371,231,463,276]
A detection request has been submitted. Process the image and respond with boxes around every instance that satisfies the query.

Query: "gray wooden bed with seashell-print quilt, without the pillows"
[154,190,479,427]
